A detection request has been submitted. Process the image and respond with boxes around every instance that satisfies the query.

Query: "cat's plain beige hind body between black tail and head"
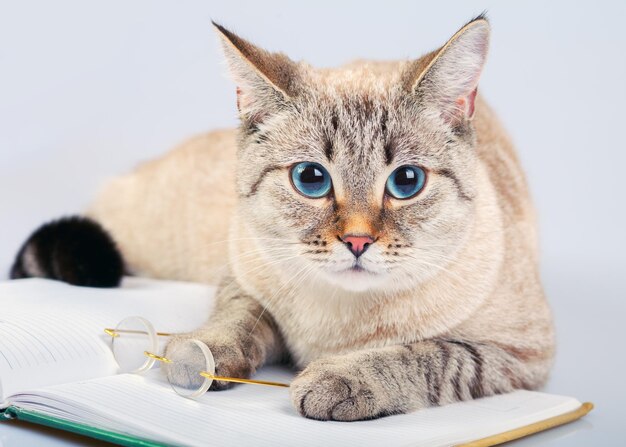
[88,130,236,284]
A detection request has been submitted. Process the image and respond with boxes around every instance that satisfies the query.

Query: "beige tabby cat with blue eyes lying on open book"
[16,16,554,421]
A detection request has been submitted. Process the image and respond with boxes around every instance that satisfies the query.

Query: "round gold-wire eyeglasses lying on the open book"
[104,317,289,399]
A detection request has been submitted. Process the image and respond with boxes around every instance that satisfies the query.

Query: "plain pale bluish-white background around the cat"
[0,0,626,447]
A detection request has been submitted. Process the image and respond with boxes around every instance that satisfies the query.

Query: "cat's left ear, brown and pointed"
[213,22,299,123]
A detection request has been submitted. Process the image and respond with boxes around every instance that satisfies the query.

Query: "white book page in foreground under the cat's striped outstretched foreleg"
[14,367,580,447]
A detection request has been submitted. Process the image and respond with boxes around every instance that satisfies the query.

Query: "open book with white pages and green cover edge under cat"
[0,278,592,446]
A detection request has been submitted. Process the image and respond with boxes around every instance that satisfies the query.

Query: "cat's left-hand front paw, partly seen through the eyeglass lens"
[165,335,253,391]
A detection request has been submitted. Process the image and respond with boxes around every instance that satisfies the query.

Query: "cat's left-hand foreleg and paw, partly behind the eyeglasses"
[165,276,285,390]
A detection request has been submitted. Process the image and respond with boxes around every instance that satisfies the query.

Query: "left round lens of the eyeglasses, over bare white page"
[111,317,157,373]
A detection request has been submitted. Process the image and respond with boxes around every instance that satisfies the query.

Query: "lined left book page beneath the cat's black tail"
[0,278,214,402]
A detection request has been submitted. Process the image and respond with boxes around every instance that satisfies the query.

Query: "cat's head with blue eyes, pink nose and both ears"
[216,17,489,291]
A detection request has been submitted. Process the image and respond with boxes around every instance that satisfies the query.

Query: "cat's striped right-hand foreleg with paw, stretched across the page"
[291,339,549,421]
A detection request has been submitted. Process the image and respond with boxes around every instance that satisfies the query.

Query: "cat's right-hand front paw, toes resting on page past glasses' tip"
[290,358,388,421]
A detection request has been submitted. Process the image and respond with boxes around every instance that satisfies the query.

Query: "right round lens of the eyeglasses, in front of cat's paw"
[163,340,215,399]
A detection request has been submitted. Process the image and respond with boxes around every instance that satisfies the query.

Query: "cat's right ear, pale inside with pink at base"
[405,16,490,125]
